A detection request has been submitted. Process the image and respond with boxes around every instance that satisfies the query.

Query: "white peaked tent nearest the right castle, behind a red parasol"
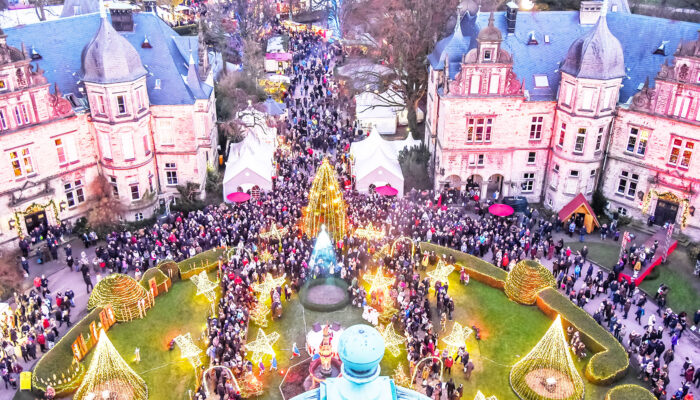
[350,129,404,196]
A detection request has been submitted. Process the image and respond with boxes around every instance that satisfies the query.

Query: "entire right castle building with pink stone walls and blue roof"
[425,0,700,234]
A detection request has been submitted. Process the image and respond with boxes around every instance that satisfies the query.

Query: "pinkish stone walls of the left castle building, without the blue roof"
[0,11,218,245]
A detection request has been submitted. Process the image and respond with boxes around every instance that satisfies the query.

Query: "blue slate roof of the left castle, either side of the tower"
[5,13,213,105]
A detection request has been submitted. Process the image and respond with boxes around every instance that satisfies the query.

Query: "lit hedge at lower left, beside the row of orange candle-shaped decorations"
[32,307,102,397]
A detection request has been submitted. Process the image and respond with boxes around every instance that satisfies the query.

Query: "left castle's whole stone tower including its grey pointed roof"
[82,3,158,219]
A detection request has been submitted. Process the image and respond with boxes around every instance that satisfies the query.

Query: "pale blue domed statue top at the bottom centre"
[292,325,430,400]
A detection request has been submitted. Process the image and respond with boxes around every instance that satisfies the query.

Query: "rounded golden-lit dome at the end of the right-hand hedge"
[504,260,556,304]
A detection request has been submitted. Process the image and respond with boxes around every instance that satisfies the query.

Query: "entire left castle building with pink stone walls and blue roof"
[0,4,217,244]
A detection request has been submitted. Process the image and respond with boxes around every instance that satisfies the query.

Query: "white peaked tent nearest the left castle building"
[223,128,275,201]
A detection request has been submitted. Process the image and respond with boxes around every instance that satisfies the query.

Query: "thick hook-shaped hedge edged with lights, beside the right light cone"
[537,288,630,385]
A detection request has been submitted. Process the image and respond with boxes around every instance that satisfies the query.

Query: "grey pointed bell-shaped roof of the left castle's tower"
[81,2,147,84]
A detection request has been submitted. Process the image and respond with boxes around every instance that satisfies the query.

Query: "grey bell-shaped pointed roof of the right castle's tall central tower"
[561,14,626,80]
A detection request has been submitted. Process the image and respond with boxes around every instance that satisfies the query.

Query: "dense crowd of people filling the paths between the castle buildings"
[1,15,700,400]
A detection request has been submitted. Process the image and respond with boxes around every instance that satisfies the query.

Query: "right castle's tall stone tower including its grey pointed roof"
[545,7,626,210]
